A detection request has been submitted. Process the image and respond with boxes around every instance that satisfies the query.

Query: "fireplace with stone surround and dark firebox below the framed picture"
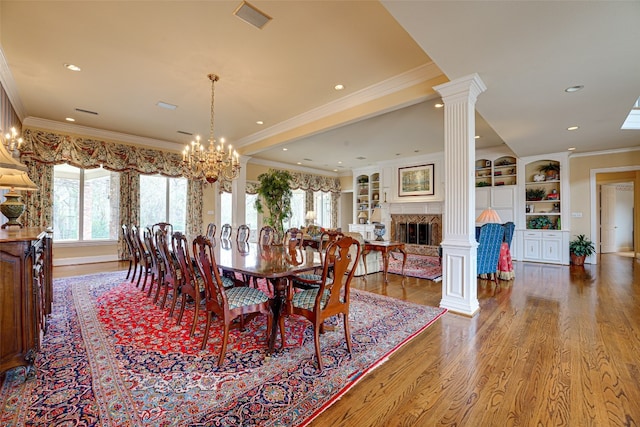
[390,214,442,256]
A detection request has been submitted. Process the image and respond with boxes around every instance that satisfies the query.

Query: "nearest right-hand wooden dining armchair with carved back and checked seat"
[279,237,360,371]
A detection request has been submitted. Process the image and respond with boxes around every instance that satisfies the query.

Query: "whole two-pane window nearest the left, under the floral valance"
[53,164,120,241]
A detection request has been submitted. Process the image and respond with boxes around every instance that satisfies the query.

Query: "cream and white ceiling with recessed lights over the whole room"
[0,0,640,174]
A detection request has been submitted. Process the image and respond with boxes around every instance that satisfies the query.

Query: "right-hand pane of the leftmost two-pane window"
[82,168,120,240]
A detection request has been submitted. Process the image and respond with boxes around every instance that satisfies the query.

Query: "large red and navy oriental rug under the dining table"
[0,272,446,427]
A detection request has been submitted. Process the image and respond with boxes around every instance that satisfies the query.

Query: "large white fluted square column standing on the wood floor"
[434,74,487,316]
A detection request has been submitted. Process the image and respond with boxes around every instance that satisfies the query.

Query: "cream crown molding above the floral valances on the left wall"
[22,117,182,152]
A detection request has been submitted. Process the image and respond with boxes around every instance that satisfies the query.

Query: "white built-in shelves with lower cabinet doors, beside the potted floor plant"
[519,153,569,264]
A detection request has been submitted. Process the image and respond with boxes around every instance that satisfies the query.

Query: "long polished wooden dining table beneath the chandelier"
[214,241,322,353]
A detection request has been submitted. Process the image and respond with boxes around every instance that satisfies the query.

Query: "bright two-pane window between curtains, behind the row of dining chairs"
[140,175,187,233]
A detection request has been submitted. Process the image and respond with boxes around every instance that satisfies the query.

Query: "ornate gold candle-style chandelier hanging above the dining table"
[182,74,240,184]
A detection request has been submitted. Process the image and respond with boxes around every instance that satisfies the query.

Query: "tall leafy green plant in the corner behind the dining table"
[255,169,293,241]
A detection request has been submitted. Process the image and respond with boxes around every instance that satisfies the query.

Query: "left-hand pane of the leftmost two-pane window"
[53,164,80,241]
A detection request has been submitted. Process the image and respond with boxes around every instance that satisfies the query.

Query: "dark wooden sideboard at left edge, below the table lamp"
[0,228,53,379]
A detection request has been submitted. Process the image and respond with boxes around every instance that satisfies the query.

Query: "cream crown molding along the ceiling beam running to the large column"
[235,62,442,148]
